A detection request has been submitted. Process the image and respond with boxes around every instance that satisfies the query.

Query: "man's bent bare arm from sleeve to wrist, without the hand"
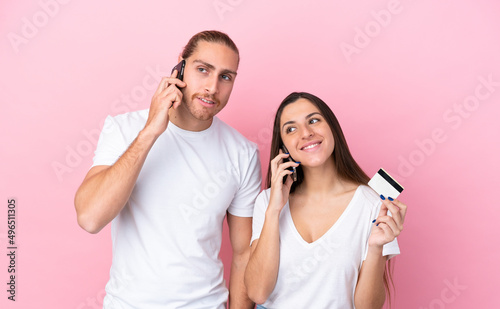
[75,130,156,233]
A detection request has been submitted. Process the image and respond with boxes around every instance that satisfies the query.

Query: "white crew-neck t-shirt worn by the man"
[93,110,261,309]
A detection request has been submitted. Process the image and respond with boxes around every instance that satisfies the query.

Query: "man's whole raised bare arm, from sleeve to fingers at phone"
[75,71,185,234]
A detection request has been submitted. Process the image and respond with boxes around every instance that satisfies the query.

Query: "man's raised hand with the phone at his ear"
[143,60,186,138]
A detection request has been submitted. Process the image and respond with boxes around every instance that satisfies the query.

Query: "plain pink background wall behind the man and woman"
[0,0,500,309]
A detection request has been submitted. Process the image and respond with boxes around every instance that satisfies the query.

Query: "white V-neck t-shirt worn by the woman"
[252,185,399,309]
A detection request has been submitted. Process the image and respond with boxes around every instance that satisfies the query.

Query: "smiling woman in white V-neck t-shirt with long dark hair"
[245,93,406,309]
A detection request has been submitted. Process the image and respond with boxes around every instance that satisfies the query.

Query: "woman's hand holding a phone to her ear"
[268,149,299,212]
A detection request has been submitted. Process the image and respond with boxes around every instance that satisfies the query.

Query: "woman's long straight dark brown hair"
[266,92,394,306]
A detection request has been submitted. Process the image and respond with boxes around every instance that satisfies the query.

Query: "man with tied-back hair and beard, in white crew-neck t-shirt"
[75,31,261,309]
